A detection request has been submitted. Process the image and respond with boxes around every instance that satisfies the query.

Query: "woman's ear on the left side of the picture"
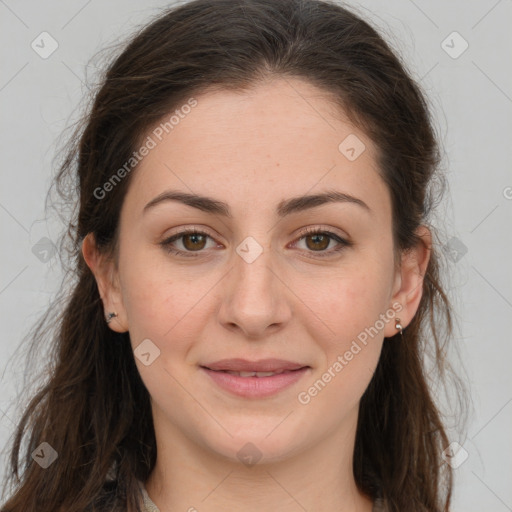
[82,233,128,332]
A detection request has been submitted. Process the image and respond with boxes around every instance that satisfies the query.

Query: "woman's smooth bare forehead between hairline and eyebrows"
[126,78,389,217]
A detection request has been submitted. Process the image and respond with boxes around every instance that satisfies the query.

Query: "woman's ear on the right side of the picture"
[384,226,432,337]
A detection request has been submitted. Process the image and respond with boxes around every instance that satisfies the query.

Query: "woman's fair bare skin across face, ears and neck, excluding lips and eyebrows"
[83,78,430,512]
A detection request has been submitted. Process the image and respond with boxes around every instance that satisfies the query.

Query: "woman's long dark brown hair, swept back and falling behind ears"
[2,0,470,512]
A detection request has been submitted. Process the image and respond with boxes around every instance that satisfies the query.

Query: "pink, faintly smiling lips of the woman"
[201,359,311,398]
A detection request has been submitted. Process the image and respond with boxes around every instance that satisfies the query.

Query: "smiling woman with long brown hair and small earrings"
[2,0,468,512]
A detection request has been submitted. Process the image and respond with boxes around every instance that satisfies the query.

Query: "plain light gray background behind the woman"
[0,0,512,512]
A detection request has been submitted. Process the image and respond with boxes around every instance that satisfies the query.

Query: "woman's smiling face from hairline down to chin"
[87,79,421,462]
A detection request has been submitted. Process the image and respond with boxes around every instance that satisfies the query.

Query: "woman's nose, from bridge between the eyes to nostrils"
[219,239,291,340]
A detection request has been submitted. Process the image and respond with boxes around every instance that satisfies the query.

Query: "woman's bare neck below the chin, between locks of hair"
[145,406,372,512]
